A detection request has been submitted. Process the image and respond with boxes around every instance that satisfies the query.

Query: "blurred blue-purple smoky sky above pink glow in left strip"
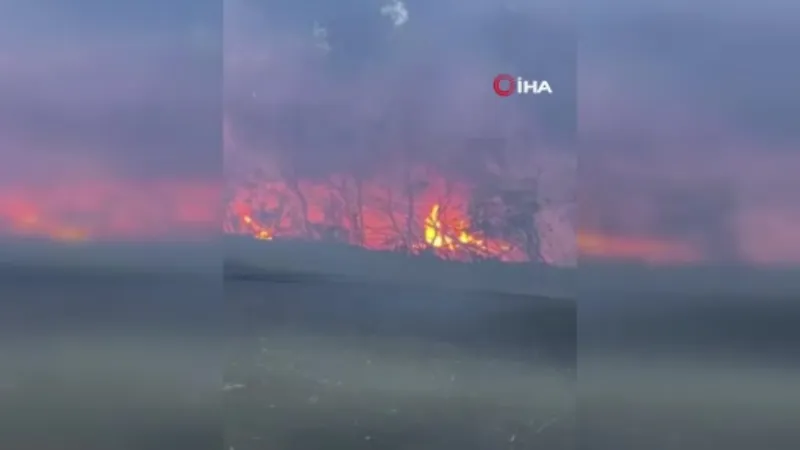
[0,0,222,183]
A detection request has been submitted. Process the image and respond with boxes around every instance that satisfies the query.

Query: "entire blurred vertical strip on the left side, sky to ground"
[0,0,222,450]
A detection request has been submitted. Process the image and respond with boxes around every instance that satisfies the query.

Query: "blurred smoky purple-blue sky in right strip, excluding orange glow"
[579,1,800,263]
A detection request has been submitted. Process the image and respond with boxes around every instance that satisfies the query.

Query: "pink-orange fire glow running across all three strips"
[0,175,703,264]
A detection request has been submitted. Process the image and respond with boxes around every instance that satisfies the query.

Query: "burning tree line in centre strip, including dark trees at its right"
[224,157,544,262]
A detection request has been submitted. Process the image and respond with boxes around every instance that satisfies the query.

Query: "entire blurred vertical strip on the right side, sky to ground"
[579,2,800,450]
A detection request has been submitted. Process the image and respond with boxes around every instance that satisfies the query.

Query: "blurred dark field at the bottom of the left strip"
[0,267,223,450]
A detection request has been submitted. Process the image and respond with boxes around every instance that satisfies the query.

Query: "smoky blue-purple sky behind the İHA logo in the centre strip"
[225,0,576,178]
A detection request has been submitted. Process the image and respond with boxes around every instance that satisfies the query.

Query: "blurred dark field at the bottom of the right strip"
[578,294,800,450]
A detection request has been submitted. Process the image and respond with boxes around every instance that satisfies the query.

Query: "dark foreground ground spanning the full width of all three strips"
[0,262,800,450]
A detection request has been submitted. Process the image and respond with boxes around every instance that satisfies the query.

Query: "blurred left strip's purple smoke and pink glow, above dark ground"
[0,0,221,244]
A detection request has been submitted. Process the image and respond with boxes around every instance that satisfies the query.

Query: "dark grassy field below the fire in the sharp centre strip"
[225,268,576,450]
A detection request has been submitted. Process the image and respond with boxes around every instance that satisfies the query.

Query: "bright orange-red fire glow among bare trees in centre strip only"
[223,170,529,262]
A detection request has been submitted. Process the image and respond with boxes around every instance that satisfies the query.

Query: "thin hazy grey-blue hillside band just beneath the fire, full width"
[0,236,800,298]
